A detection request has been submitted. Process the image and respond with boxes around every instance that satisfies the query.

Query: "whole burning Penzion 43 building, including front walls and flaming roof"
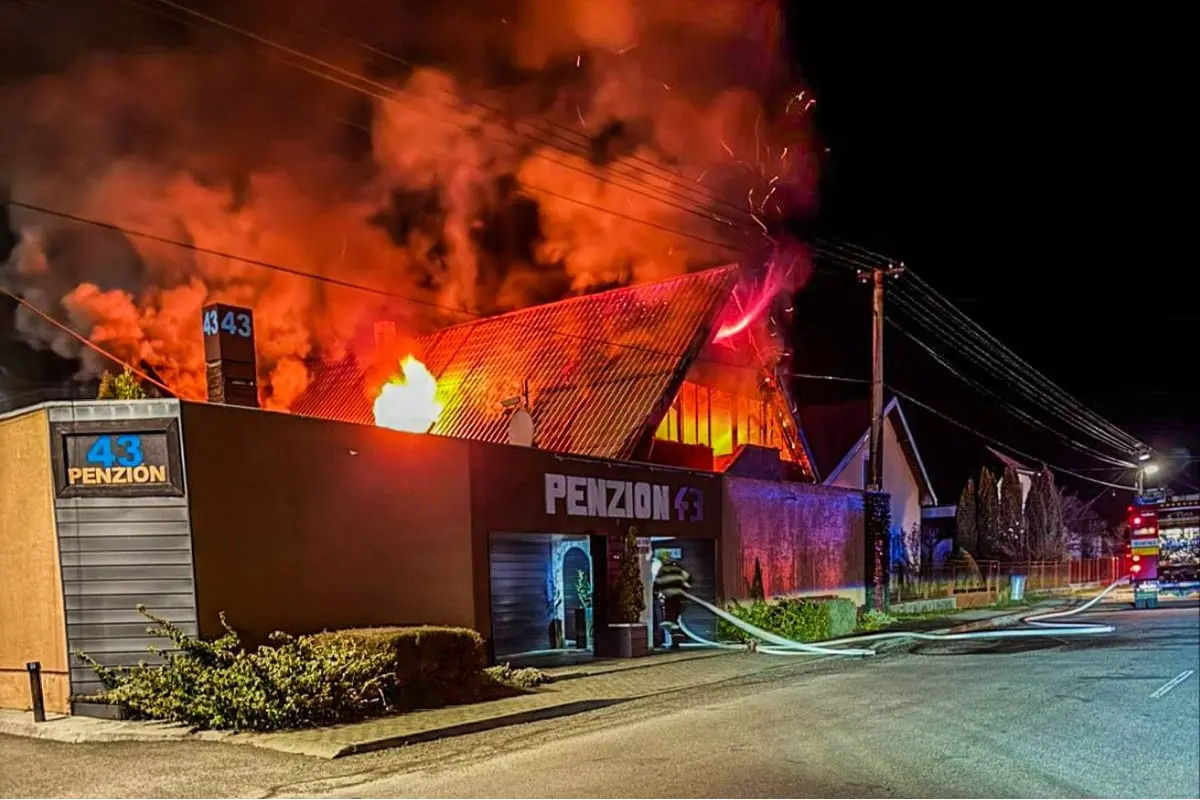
[0,266,878,712]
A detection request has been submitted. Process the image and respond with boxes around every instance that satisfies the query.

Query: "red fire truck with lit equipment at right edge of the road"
[1124,492,1200,608]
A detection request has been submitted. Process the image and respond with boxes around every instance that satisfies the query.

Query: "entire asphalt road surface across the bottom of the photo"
[0,602,1200,798]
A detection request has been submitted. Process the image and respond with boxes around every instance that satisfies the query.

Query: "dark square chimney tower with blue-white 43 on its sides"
[202,302,258,408]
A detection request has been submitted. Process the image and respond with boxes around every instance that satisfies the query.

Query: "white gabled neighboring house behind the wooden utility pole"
[799,397,937,559]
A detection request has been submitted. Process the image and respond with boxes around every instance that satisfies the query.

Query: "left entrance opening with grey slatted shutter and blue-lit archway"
[488,533,594,662]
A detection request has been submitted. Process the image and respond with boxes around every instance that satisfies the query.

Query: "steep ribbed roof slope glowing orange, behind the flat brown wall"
[290,265,740,458]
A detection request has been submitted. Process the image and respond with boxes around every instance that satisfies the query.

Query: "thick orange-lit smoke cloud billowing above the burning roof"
[0,0,812,408]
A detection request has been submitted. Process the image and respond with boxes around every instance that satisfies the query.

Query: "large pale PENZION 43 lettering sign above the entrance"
[545,473,704,522]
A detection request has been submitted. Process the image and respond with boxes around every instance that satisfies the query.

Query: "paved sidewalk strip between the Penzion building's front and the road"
[0,601,1080,758]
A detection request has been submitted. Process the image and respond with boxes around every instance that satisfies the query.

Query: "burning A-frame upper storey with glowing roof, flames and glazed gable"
[292,265,814,481]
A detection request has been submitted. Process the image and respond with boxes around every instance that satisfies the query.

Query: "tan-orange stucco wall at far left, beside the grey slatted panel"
[0,410,70,714]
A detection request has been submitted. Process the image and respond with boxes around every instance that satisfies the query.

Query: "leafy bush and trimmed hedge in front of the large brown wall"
[77,606,501,730]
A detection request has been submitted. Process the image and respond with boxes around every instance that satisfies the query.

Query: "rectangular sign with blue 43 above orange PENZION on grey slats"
[55,420,184,497]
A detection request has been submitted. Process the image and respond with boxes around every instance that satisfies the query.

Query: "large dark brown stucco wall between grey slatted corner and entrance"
[182,403,475,640]
